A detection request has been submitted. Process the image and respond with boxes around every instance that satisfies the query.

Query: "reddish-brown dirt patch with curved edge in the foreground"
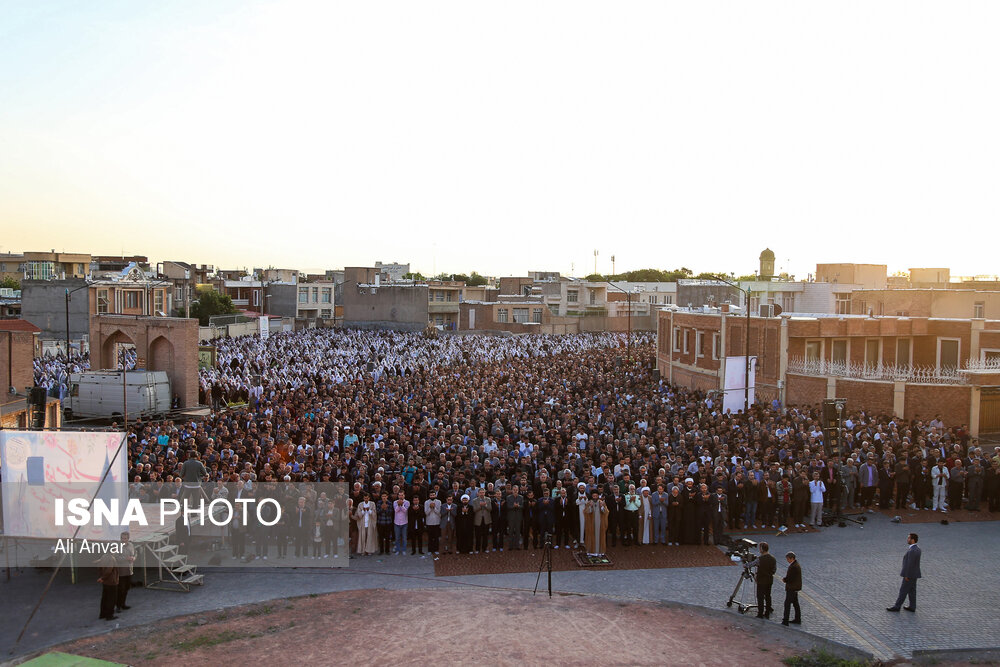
[56,589,808,667]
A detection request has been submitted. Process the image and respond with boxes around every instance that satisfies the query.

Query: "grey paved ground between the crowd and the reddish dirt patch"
[0,514,1000,659]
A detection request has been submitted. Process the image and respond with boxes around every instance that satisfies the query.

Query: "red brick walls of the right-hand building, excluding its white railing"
[657,311,1000,433]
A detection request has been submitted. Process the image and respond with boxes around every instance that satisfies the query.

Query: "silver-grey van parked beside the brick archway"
[64,370,172,419]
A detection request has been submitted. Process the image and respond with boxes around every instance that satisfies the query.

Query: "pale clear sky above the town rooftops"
[0,0,1000,277]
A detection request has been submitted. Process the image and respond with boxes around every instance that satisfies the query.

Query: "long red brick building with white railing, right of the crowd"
[657,309,1000,434]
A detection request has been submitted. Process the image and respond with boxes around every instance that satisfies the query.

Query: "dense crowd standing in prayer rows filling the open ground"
[113,329,1000,557]
